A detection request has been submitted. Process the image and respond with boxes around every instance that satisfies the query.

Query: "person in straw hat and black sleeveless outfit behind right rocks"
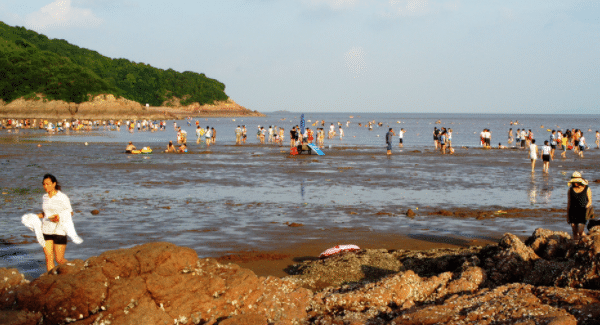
[567,172,592,241]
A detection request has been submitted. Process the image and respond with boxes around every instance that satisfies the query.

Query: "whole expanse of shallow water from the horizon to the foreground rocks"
[0,112,600,276]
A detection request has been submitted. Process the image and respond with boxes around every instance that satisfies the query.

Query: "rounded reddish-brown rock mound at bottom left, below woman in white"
[0,243,311,324]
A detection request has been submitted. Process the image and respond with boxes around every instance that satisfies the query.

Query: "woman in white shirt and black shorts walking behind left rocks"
[38,174,83,271]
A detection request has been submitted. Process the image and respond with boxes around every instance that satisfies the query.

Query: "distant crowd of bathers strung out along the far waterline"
[5,117,600,161]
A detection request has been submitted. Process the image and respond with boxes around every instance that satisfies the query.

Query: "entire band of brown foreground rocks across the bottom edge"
[0,227,600,325]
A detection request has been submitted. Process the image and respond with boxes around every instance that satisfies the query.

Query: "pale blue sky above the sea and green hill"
[0,0,600,114]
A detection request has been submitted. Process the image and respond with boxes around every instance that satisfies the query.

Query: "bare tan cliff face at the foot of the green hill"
[0,94,264,119]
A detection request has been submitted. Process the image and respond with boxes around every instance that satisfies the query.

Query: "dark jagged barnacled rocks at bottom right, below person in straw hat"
[288,229,600,324]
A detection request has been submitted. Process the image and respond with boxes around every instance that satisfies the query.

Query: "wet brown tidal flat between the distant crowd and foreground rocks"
[0,135,600,276]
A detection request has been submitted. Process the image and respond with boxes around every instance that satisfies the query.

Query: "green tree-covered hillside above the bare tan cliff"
[0,22,228,106]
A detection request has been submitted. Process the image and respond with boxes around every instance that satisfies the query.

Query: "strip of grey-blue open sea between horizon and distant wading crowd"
[21,112,600,148]
